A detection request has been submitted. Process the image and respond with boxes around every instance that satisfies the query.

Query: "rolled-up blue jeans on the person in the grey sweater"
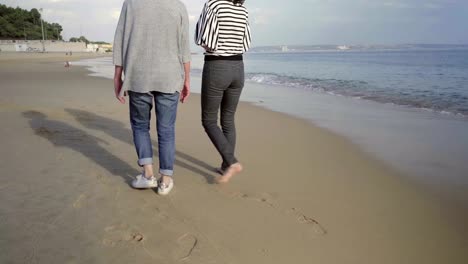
[128,91,179,176]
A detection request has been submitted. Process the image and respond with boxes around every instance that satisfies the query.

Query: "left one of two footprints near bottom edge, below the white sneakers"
[102,224,144,247]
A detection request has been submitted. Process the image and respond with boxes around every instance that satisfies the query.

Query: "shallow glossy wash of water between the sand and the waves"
[77,54,468,206]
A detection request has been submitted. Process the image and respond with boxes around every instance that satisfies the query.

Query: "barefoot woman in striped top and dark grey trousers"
[195,0,251,183]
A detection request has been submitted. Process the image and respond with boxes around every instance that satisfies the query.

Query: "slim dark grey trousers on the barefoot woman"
[201,60,244,169]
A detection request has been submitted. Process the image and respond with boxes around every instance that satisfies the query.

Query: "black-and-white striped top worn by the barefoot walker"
[195,0,251,56]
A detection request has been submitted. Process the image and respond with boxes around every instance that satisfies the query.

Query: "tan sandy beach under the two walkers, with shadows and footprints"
[0,53,468,264]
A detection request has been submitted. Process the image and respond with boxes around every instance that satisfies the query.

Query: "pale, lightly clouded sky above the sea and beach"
[0,0,468,46]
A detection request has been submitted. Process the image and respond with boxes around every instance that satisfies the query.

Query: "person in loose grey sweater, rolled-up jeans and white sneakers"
[114,0,191,195]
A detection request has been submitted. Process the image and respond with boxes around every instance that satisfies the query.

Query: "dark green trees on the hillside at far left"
[0,4,63,40]
